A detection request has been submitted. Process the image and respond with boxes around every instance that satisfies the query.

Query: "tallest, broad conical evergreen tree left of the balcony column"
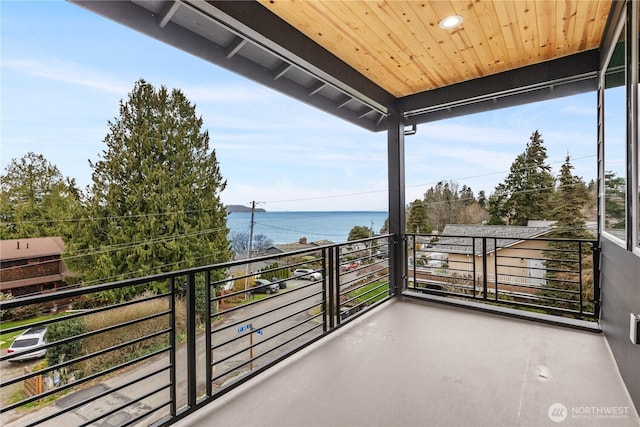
[70,80,231,300]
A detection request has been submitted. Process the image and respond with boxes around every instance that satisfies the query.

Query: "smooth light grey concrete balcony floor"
[177,301,640,427]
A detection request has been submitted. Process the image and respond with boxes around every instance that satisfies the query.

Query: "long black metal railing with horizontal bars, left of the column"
[0,236,393,426]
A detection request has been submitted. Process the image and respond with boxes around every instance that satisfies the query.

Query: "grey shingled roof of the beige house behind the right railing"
[422,224,552,255]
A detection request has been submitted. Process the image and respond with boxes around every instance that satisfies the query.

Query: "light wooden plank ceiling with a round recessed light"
[259,0,611,98]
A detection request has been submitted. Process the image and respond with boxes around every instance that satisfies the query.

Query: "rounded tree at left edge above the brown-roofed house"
[0,152,82,242]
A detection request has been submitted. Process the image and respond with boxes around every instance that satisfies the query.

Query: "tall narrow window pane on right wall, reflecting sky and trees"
[604,23,627,240]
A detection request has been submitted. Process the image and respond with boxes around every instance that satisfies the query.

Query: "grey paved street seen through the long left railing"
[0,279,322,427]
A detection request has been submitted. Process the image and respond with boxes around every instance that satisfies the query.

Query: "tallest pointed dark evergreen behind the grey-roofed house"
[490,130,554,225]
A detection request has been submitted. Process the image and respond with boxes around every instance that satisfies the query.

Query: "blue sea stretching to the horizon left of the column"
[227,211,389,244]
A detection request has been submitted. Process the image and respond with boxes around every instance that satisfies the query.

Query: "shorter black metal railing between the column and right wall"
[405,234,600,319]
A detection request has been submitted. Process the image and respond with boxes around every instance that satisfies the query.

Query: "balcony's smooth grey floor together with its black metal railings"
[0,235,639,426]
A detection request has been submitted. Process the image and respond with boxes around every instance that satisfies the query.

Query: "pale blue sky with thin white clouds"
[0,0,597,211]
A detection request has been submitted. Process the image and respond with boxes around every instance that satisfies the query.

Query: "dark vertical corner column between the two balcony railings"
[387,113,407,296]
